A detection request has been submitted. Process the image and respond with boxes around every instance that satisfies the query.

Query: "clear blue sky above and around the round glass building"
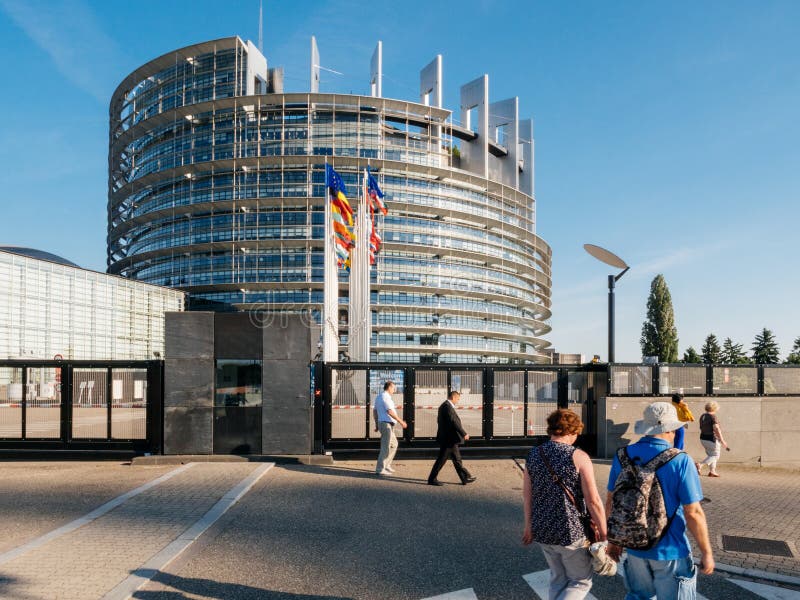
[0,0,800,361]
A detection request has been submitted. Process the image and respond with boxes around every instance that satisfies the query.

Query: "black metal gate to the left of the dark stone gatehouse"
[0,360,163,454]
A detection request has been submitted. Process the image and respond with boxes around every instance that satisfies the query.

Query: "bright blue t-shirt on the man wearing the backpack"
[608,436,703,560]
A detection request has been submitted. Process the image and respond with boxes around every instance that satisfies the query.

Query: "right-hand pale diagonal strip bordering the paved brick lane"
[102,463,274,600]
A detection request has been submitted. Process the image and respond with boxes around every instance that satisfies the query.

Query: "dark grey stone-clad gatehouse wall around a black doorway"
[164,312,320,454]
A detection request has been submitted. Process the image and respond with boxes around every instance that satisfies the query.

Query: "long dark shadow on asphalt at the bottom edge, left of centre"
[131,571,353,600]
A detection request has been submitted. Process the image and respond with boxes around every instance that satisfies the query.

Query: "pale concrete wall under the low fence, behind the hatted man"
[597,396,800,468]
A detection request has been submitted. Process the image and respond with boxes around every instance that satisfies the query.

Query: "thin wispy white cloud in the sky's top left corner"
[0,0,119,104]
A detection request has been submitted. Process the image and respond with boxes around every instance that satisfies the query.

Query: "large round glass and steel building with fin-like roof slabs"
[108,37,551,363]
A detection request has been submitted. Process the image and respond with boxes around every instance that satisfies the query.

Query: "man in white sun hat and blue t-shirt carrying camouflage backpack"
[606,402,714,600]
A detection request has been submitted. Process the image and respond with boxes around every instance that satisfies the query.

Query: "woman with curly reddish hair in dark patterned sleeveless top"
[522,409,606,600]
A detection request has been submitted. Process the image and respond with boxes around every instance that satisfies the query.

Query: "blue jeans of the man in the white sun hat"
[625,554,697,600]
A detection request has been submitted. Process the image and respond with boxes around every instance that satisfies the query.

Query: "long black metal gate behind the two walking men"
[314,363,608,452]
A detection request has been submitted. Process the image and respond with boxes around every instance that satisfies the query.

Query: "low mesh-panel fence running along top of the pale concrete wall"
[609,364,800,396]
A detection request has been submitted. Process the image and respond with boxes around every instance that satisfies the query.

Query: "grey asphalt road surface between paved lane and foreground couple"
[134,460,792,600]
